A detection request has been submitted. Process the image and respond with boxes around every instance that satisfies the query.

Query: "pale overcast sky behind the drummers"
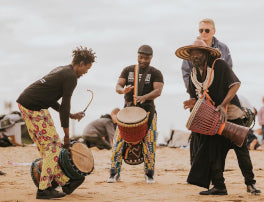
[0,0,264,139]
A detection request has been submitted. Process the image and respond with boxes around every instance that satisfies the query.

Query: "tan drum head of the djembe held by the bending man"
[70,142,94,173]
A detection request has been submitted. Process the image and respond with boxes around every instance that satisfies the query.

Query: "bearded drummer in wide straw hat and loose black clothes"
[175,40,260,195]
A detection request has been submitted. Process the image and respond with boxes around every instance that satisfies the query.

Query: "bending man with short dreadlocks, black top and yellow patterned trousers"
[17,46,96,199]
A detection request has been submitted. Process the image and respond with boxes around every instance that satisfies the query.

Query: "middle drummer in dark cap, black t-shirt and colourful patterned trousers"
[108,45,163,183]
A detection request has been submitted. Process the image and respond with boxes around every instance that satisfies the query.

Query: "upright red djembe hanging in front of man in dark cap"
[117,107,148,165]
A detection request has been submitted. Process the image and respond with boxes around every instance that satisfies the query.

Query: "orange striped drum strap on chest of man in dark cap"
[133,65,150,106]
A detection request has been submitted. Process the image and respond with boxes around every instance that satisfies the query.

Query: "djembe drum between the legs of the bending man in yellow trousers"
[30,142,94,185]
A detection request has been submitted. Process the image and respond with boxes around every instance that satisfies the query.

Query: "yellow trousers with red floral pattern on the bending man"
[18,104,69,190]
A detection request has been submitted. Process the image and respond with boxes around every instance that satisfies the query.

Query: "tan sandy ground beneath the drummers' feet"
[0,146,264,202]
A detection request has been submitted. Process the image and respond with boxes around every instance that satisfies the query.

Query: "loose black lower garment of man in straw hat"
[187,133,227,189]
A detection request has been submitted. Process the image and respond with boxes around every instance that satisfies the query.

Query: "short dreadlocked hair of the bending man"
[72,46,96,65]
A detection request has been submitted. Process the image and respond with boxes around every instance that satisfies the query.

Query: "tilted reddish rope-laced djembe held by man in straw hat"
[186,97,249,147]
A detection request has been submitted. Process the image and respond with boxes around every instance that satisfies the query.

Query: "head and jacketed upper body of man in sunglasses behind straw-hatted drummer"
[181,18,233,89]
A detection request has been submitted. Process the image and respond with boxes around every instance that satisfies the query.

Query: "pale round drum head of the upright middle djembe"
[116,107,147,124]
